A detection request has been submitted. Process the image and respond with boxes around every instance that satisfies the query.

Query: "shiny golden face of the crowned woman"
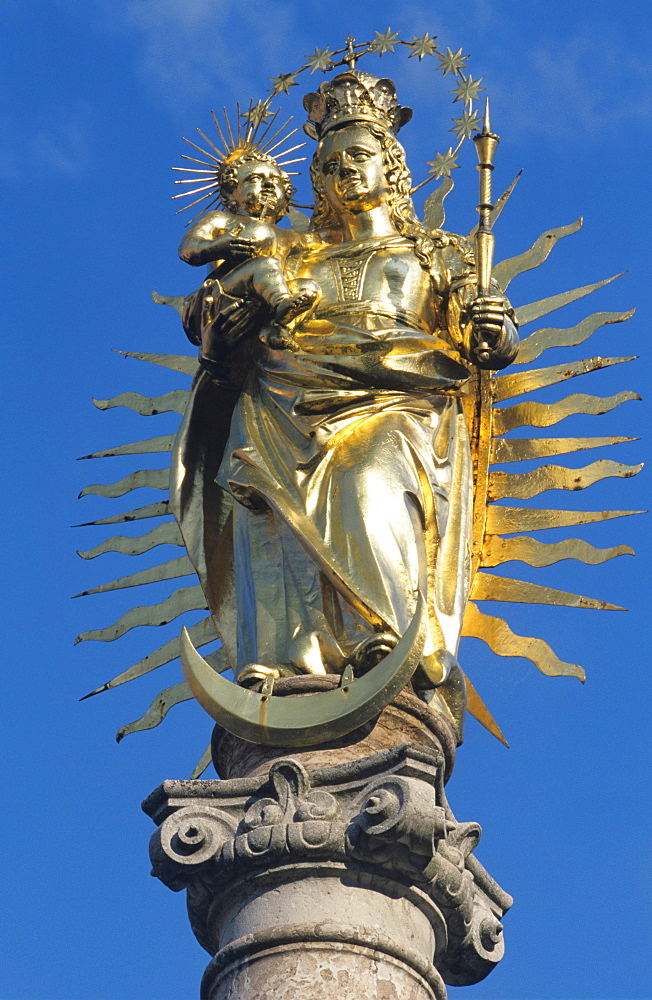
[320,125,389,214]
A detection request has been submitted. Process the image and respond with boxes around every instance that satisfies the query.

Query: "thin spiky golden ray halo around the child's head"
[172,101,306,226]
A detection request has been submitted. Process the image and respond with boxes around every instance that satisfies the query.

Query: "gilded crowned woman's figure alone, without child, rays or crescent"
[172,70,518,744]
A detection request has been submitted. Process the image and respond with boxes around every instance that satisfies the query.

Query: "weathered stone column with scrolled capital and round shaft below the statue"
[144,740,511,1000]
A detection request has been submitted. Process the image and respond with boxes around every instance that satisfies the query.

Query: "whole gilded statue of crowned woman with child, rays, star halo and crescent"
[77,29,637,773]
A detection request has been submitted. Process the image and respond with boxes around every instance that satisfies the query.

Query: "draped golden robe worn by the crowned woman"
[171,236,515,732]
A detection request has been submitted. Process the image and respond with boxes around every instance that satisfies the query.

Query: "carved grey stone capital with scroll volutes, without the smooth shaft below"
[143,744,511,985]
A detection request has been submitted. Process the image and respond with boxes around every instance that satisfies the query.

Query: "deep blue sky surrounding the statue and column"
[0,0,652,1000]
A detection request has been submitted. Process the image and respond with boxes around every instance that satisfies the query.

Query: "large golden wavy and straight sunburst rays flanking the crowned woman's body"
[77,156,640,777]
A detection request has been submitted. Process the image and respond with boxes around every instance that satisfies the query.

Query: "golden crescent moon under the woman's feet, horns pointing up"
[181,594,426,747]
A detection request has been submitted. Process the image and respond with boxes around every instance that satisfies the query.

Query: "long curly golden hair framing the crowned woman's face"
[310,122,435,270]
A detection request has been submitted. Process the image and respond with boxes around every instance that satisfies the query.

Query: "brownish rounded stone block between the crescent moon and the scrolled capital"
[213,674,456,780]
